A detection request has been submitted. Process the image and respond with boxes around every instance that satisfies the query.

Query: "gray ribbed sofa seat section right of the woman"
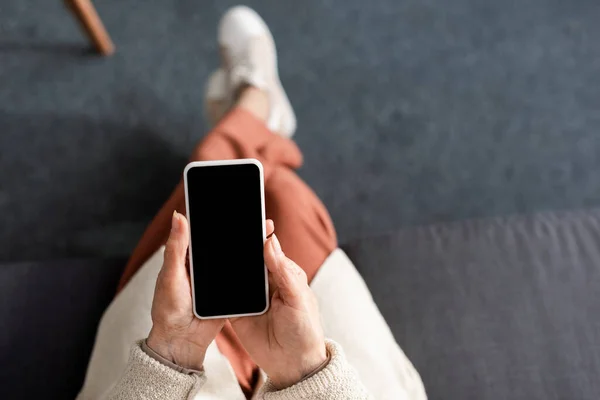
[345,210,600,400]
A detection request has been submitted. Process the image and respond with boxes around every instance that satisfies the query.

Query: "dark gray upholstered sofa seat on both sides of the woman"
[0,210,600,400]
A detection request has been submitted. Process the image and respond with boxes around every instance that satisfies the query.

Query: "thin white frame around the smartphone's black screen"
[183,158,270,319]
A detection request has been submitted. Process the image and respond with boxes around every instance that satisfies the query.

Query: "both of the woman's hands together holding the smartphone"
[146,213,327,388]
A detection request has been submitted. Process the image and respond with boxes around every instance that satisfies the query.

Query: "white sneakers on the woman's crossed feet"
[206,6,296,137]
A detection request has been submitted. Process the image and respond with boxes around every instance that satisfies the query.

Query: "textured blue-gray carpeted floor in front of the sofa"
[0,0,600,260]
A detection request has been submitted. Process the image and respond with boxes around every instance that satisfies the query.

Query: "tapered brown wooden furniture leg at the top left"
[65,0,115,56]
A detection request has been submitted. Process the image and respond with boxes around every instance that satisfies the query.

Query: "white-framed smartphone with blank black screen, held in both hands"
[183,159,269,319]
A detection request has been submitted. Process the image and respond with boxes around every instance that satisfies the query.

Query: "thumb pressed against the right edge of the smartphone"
[265,234,308,306]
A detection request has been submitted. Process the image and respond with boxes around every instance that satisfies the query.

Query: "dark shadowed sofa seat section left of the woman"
[0,260,124,399]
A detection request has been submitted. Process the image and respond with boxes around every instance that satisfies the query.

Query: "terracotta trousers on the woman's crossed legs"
[119,108,337,397]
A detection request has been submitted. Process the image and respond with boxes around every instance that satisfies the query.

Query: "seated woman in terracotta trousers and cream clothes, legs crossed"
[79,6,426,400]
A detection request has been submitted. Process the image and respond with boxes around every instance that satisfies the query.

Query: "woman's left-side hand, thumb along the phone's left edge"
[146,212,225,370]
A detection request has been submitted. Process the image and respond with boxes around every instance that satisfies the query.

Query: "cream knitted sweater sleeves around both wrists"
[108,340,371,400]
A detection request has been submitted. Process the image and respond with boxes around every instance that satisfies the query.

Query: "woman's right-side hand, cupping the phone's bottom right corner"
[230,230,327,389]
